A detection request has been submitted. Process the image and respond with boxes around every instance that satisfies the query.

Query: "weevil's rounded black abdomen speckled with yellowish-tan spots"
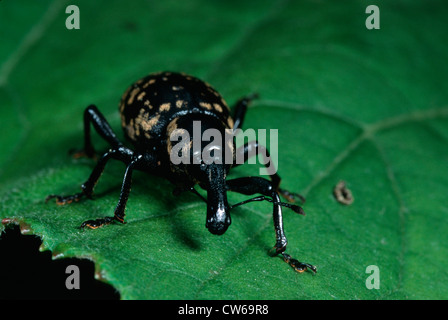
[120,72,233,145]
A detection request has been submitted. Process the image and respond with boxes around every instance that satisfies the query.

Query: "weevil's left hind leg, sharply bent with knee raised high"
[73,104,122,158]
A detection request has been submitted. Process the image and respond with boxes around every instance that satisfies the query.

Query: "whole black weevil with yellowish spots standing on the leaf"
[46,72,316,272]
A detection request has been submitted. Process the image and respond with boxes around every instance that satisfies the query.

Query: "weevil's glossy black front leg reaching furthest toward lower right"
[226,177,316,272]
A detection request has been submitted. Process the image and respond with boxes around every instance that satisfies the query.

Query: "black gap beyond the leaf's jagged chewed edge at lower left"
[0,226,120,299]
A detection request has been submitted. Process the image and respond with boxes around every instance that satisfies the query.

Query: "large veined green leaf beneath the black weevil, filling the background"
[0,0,448,299]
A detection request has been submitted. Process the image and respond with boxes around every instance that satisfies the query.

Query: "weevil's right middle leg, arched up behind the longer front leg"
[233,141,305,203]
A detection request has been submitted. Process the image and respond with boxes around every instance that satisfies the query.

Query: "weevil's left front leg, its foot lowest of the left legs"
[81,156,142,229]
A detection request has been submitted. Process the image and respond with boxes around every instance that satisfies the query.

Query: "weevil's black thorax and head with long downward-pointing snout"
[167,114,234,235]
